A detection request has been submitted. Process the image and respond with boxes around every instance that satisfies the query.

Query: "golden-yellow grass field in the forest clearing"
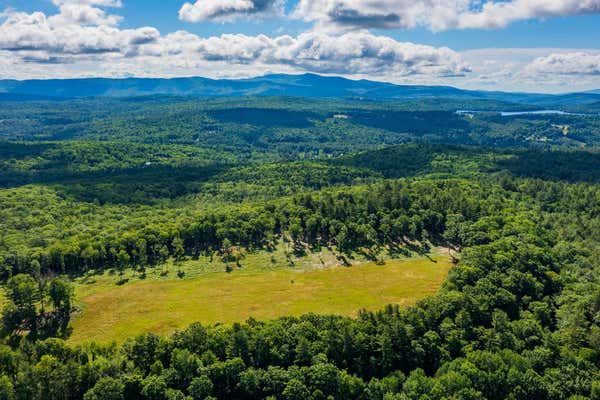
[70,256,451,343]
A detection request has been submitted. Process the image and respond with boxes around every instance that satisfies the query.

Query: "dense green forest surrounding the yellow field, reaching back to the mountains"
[0,97,600,400]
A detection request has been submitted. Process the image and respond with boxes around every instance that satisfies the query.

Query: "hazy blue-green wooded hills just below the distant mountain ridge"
[0,96,600,150]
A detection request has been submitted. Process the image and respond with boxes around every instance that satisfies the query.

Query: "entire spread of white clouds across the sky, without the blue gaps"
[0,0,600,91]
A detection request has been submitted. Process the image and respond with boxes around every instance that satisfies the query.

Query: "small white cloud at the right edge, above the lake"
[526,52,600,76]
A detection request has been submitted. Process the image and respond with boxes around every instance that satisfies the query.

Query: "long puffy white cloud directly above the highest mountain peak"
[141,31,469,77]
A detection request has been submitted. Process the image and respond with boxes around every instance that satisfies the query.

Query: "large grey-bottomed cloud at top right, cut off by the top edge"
[293,0,600,31]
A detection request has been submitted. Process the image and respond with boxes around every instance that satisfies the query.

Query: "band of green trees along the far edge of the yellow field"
[0,180,504,279]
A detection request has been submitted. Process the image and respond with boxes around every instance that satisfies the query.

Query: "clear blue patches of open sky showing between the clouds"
[0,0,600,50]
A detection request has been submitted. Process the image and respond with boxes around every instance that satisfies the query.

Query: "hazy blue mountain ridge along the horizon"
[0,74,600,106]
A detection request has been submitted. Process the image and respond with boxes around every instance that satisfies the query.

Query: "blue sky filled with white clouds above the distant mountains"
[0,0,600,93]
